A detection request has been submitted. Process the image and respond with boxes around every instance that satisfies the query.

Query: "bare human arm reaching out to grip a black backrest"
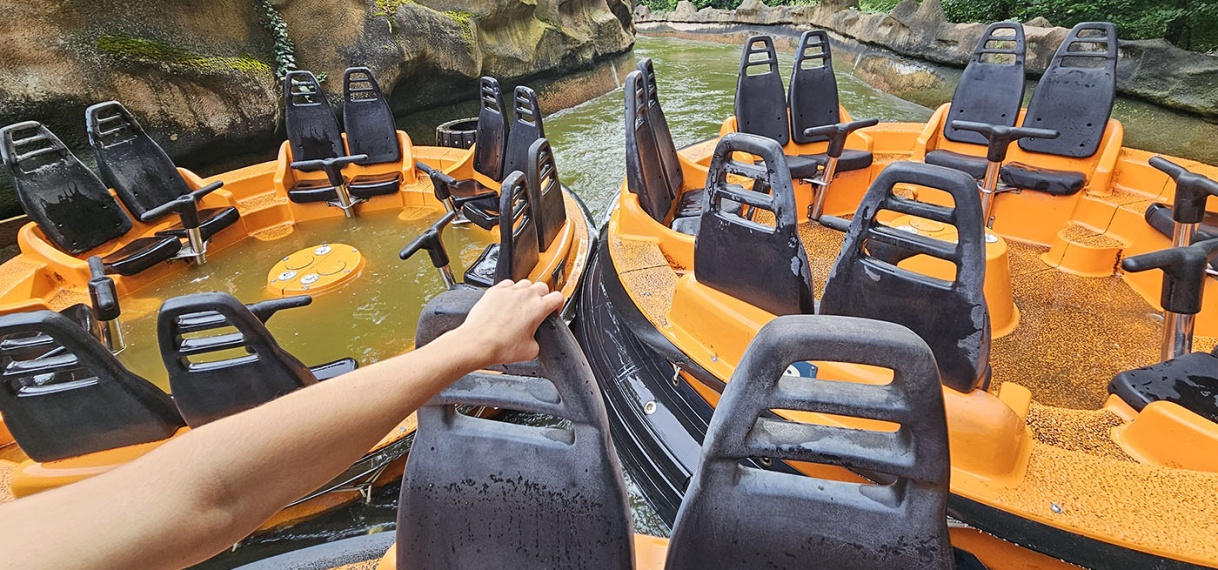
[0,281,563,569]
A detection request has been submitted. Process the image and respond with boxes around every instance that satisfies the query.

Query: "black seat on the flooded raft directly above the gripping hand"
[465,171,538,287]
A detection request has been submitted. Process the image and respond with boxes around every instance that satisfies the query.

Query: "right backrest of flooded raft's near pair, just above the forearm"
[157,292,317,428]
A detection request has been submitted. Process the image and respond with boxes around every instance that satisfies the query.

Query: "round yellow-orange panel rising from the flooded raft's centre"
[267,244,364,297]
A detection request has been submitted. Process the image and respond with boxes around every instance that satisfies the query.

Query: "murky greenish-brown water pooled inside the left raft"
[119,211,491,390]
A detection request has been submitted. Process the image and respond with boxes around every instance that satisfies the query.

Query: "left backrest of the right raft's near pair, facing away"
[693,133,814,314]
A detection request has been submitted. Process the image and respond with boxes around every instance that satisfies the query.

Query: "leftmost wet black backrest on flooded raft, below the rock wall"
[0,121,132,255]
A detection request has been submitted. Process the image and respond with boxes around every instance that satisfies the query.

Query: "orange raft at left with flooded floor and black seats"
[0,67,594,530]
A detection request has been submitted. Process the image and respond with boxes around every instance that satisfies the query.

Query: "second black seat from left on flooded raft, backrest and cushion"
[84,101,240,240]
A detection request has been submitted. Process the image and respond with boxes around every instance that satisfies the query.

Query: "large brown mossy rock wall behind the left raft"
[0,0,633,218]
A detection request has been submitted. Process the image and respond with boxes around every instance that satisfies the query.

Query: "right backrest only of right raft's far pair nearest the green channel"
[788,29,842,143]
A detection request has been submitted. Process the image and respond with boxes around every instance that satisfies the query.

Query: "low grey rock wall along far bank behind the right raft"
[636,0,1218,119]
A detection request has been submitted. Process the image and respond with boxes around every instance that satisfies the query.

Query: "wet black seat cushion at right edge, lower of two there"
[1108,352,1218,421]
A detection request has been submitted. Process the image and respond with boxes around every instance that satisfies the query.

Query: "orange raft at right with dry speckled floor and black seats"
[576,23,1218,568]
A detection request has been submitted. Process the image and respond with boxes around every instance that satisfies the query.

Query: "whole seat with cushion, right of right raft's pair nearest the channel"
[787,29,872,178]
